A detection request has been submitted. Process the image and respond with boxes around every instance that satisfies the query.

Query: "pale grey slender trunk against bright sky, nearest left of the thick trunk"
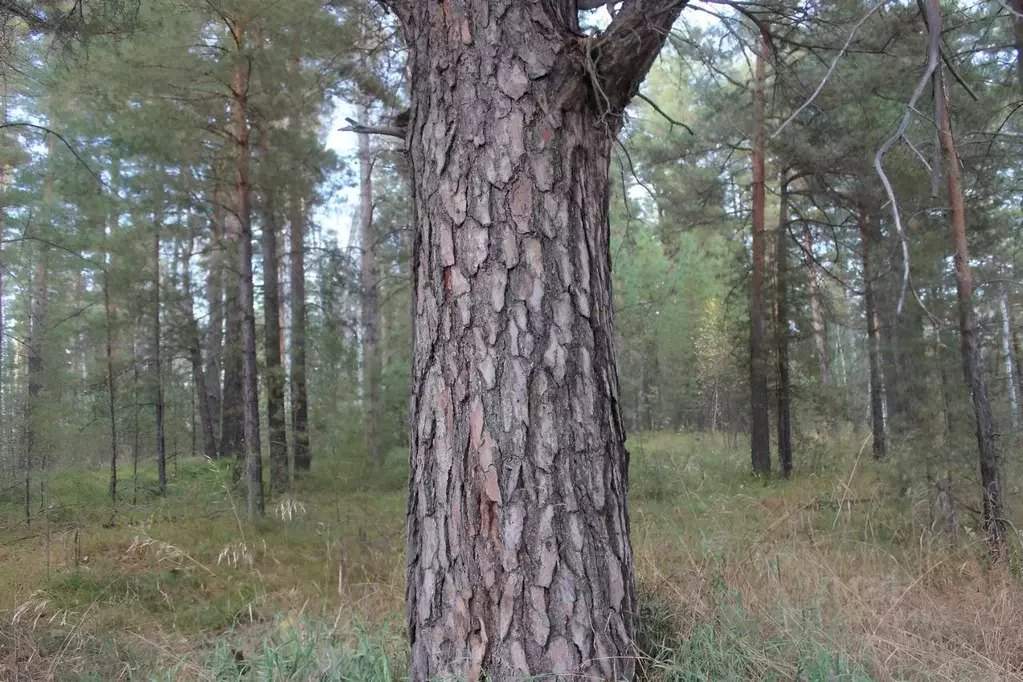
[359,108,383,465]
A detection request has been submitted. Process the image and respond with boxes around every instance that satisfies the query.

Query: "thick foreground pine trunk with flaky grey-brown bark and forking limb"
[389,0,683,682]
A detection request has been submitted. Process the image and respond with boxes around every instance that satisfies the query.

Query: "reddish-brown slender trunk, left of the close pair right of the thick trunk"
[750,33,770,473]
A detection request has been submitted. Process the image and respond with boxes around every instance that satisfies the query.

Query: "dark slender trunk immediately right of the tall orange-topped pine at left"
[261,133,288,494]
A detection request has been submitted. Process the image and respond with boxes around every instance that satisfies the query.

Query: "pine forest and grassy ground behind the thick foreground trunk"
[0,0,1023,680]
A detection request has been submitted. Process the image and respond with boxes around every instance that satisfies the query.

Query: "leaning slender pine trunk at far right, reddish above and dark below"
[926,5,1006,560]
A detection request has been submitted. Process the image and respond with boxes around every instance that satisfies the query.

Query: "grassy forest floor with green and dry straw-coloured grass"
[0,434,1023,682]
